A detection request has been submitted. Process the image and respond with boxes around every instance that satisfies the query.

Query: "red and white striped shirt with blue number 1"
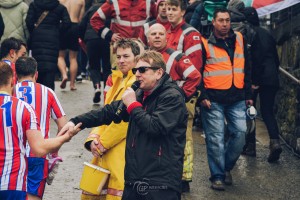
[0,93,39,191]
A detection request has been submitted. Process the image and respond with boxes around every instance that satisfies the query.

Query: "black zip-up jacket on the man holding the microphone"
[70,73,188,192]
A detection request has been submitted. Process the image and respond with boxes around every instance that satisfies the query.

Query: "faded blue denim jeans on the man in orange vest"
[201,101,247,181]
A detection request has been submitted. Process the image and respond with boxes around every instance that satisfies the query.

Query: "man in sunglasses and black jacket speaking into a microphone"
[59,51,188,200]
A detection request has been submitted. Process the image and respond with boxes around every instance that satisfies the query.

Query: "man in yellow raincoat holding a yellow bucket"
[81,39,140,200]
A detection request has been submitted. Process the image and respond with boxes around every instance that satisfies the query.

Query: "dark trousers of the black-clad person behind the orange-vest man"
[247,86,279,143]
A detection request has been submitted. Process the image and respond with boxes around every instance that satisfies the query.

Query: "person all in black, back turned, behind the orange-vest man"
[243,7,282,163]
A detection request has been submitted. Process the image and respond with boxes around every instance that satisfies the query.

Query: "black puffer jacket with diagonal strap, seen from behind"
[26,0,71,72]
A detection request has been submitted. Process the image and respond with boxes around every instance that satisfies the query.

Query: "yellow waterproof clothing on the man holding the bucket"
[81,70,136,200]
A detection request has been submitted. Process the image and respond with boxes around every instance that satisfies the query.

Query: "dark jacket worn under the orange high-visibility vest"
[199,30,252,104]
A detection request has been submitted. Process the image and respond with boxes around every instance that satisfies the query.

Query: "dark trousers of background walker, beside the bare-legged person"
[86,39,111,89]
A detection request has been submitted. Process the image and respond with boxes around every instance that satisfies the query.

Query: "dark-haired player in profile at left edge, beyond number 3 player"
[0,37,26,84]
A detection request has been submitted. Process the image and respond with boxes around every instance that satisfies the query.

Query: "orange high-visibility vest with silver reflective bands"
[202,32,245,90]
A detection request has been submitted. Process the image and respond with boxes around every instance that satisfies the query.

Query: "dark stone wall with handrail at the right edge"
[273,23,300,154]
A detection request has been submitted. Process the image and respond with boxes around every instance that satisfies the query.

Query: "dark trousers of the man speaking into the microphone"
[122,184,181,200]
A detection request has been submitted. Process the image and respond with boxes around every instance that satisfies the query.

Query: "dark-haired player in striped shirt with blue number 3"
[14,57,67,199]
